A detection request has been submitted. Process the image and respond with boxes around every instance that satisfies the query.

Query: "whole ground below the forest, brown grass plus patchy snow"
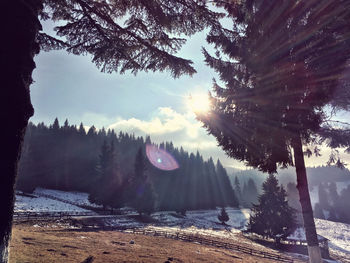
[11,189,350,263]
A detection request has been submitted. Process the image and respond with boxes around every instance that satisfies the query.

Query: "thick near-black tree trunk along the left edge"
[0,0,42,263]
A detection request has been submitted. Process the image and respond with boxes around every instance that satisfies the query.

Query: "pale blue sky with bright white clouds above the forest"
[31,22,348,169]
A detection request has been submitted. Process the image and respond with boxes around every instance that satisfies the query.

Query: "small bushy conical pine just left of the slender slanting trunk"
[247,174,296,244]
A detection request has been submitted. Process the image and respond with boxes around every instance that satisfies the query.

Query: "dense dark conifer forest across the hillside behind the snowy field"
[17,118,238,214]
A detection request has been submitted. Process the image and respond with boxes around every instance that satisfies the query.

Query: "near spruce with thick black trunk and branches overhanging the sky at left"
[0,0,218,263]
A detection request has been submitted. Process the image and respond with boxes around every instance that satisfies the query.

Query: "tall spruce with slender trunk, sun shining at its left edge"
[198,0,350,263]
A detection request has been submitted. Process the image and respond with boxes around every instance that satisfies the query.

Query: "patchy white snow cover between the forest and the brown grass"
[15,189,350,262]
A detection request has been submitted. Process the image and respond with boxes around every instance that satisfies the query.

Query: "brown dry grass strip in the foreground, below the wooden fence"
[10,224,306,263]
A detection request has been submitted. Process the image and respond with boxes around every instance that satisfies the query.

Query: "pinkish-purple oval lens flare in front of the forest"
[146,144,179,171]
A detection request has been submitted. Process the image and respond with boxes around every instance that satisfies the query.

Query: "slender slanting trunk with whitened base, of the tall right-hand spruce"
[292,136,322,263]
